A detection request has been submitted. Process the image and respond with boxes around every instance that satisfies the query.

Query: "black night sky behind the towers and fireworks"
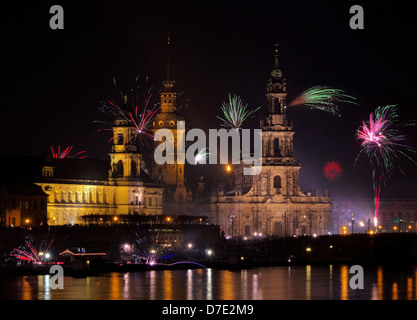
[0,0,417,197]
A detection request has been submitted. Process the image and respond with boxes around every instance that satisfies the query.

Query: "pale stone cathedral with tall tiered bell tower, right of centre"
[189,47,332,237]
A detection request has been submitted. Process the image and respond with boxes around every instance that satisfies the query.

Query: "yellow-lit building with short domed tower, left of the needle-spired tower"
[35,111,163,225]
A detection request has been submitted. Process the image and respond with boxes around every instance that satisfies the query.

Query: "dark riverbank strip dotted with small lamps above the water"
[0,227,417,275]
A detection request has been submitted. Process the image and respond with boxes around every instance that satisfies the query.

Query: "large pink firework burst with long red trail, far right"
[355,105,417,226]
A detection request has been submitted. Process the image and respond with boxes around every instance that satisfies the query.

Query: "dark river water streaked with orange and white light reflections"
[0,265,417,300]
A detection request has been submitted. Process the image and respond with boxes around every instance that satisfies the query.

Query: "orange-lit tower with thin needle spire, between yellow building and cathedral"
[152,37,187,213]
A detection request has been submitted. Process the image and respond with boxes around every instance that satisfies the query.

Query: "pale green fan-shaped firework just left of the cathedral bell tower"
[217,93,260,131]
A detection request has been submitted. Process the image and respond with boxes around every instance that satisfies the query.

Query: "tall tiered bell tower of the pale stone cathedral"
[255,45,301,197]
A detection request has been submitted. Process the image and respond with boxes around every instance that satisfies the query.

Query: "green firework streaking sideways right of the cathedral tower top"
[288,86,357,117]
